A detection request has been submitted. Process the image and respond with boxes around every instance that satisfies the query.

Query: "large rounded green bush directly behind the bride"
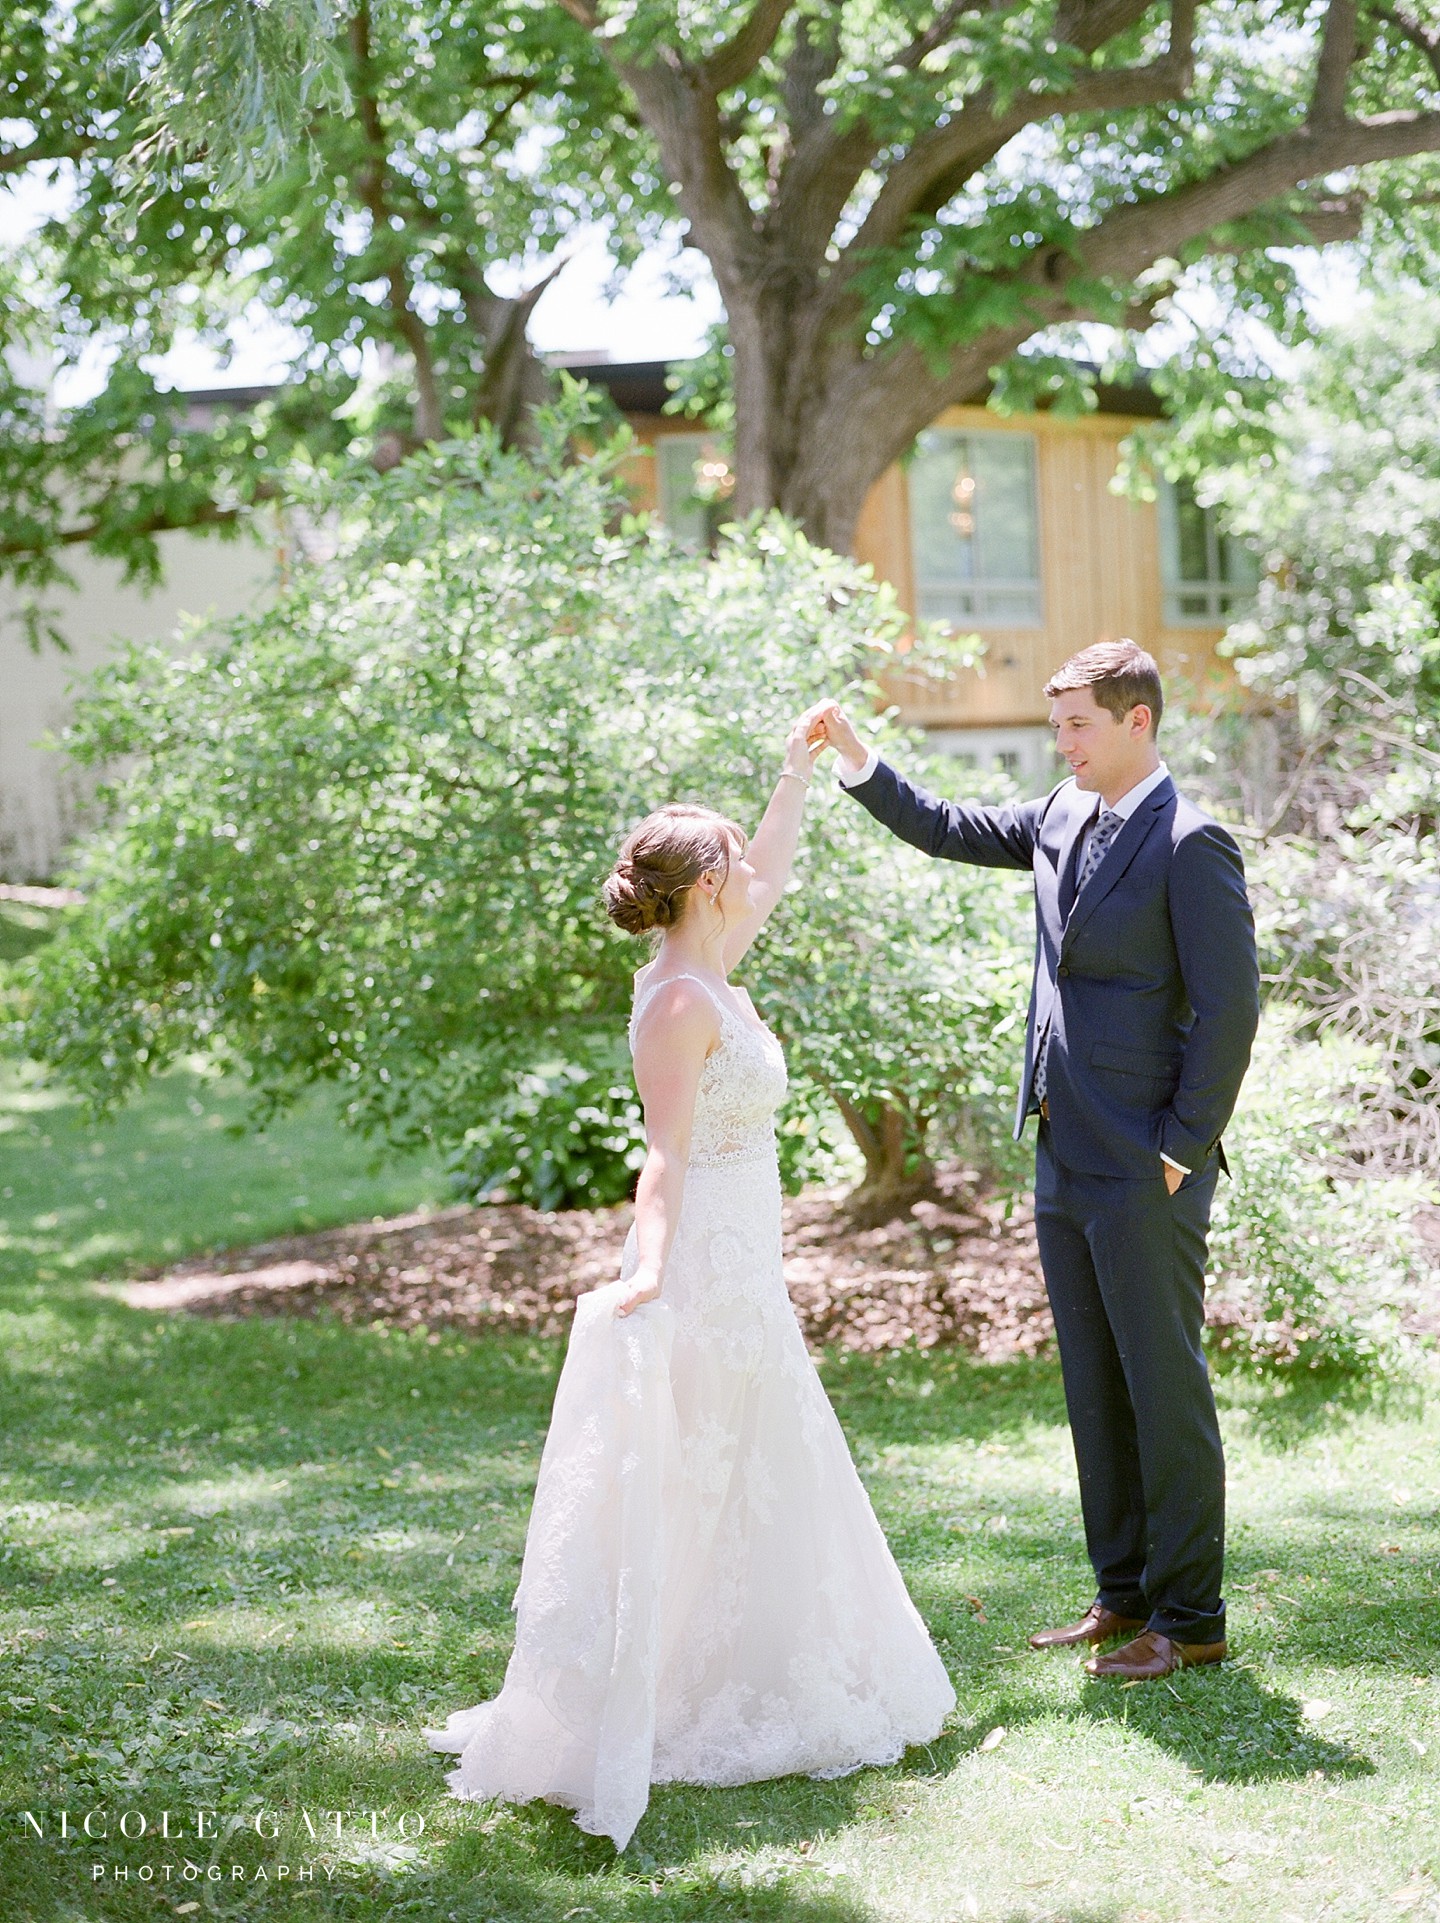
[14,386,1029,1194]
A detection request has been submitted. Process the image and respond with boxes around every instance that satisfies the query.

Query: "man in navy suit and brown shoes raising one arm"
[817,640,1259,1681]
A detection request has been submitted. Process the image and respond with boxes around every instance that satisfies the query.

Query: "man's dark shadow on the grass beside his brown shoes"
[1075,1663,1375,1783]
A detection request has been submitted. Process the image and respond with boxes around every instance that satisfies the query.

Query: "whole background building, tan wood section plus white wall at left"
[0,358,1254,881]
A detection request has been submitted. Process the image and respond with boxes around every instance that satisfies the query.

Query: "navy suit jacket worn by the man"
[850,762,1259,1177]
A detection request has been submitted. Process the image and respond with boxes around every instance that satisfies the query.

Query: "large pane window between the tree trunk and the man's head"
[909,427,1040,627]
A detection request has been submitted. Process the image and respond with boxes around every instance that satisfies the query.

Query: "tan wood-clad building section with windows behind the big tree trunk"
[595,363,1255,788]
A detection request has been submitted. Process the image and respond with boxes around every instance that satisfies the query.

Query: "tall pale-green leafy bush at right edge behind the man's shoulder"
[1153,294,1440,1179]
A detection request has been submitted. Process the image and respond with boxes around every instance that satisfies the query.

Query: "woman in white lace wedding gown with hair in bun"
[425,710,956,1850]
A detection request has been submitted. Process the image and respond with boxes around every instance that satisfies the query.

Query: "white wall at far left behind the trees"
[0,533,275,881]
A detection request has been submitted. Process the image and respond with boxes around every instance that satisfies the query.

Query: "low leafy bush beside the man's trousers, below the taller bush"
[1209,1004,1440,1375]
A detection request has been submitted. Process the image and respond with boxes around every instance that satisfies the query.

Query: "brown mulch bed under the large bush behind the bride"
[117,1186,1054,1360]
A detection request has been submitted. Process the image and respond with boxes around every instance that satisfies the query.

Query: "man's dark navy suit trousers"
[1034,1121,1225,1642]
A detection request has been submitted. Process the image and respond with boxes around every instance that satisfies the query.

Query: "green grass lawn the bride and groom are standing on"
[0,1077,1440,1923]
